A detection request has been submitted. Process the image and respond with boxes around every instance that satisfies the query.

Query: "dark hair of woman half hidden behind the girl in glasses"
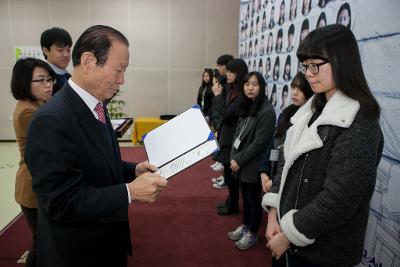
[275,72,314,137]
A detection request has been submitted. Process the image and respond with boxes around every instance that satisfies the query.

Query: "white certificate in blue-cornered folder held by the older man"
[143,106,219,179]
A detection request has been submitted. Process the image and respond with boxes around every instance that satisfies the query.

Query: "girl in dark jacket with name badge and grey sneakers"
[228,72,276,250]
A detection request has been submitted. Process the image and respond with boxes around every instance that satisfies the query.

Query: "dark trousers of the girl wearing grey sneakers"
[240,181,262,233]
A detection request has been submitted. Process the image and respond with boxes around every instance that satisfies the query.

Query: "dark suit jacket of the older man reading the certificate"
[25,83,135,267]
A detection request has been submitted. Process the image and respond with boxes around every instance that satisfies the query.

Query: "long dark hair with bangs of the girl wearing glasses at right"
[297,24,380,120]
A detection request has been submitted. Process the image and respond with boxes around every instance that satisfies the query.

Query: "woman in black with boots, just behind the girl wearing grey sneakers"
[215,59,248,215]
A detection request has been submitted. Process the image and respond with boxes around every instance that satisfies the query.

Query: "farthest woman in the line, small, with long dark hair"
[197,69,214,117]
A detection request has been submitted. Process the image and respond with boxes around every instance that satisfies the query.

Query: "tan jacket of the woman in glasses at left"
[13,100,40,208]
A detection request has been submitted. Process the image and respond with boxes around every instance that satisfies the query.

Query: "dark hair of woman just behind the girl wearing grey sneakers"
[226,58,249,100]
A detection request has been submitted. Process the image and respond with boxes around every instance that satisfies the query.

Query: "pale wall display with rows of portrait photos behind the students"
[239,0,400,267]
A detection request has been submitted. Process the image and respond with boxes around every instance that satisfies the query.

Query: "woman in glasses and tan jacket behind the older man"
[11,58,55,266]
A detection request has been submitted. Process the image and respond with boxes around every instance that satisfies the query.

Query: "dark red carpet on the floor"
[0,147,271,267]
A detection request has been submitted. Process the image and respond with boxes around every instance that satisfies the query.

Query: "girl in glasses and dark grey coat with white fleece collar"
[263,24,383,267]
